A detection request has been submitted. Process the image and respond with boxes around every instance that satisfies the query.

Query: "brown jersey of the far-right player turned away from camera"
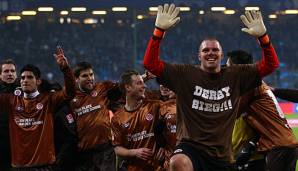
[245,83,298,151]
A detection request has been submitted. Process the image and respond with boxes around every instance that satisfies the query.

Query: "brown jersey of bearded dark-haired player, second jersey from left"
[70,82,116,150]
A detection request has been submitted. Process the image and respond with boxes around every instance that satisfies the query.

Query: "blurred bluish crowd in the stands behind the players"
[0,12,298,87]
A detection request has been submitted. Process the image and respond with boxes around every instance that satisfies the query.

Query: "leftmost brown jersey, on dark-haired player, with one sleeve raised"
[0,67,75,167]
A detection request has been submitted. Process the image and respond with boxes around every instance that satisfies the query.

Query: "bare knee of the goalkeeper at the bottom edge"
[170,154,192,171]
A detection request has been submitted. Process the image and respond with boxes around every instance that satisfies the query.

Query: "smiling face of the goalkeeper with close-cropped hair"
[199,40,223,73]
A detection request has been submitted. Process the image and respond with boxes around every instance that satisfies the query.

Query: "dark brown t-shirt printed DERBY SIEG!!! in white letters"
[159,63,261,161]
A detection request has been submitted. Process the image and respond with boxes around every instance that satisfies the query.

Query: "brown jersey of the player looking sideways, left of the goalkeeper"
[112,100,160,171]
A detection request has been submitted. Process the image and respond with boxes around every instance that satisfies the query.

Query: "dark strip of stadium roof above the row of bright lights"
[0,0,298,12]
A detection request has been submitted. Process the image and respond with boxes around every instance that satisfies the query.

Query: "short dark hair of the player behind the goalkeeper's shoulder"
[227,49,253,64]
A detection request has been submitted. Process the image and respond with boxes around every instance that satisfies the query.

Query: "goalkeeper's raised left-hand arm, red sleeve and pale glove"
[143,4,180,76]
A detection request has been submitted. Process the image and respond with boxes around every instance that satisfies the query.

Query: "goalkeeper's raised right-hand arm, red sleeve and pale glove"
[240,11,279,77]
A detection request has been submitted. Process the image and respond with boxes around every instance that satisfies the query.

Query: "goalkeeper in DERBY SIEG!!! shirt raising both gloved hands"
[143,4,279,171]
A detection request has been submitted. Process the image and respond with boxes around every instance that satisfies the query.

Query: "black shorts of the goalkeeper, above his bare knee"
[173,142,231,171]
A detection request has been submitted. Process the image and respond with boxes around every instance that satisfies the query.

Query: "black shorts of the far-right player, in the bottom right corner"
[266,147,298,171]
